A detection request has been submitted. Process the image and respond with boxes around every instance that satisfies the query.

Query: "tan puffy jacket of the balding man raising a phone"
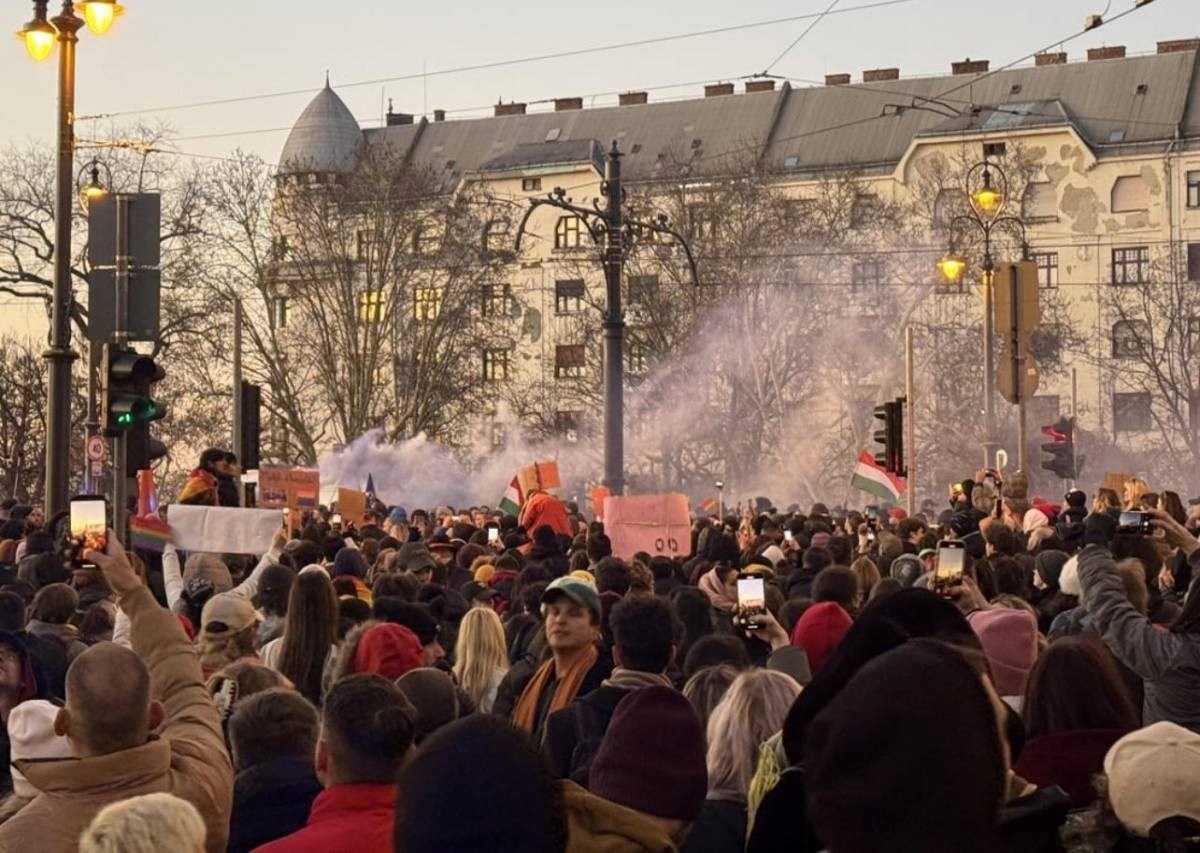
[0,587,233,853]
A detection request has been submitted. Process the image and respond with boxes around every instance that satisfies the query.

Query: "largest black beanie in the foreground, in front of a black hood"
[802,643,1006,853]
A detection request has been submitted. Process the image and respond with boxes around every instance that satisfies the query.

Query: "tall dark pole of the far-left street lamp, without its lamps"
[42,6,83,517]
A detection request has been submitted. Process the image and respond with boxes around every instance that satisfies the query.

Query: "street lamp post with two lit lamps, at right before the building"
[937,160,1028,468]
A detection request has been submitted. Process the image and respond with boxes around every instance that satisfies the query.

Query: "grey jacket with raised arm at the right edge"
[1079,546,1200,733]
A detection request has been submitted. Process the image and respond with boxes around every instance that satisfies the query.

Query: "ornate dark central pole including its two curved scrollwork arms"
[516,140,700,495]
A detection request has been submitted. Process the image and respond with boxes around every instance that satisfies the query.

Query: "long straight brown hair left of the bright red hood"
[280,571,337,705]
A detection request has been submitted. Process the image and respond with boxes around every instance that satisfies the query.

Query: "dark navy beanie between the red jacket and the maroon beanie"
[396,715,564,853]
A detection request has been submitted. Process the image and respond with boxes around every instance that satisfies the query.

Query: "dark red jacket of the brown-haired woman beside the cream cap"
[1013,728,1127,809]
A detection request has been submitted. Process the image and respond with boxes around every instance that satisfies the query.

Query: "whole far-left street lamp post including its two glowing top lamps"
[17,0,125,517]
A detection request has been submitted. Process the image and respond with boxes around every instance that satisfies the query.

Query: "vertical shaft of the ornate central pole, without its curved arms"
[602,140,625,494]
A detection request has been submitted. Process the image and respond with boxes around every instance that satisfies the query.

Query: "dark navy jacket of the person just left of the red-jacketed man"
[229,756,320,853]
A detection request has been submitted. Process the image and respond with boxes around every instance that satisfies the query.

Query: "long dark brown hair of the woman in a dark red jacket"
[1024,637,1138,739]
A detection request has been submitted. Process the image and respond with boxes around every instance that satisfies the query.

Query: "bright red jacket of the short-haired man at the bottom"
[254,783,396,853]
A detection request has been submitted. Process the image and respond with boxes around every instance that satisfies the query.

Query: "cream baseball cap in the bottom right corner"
[1104,721,1200,836]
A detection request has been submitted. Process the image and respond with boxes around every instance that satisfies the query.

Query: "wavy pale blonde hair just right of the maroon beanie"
[707,669,800,800]
